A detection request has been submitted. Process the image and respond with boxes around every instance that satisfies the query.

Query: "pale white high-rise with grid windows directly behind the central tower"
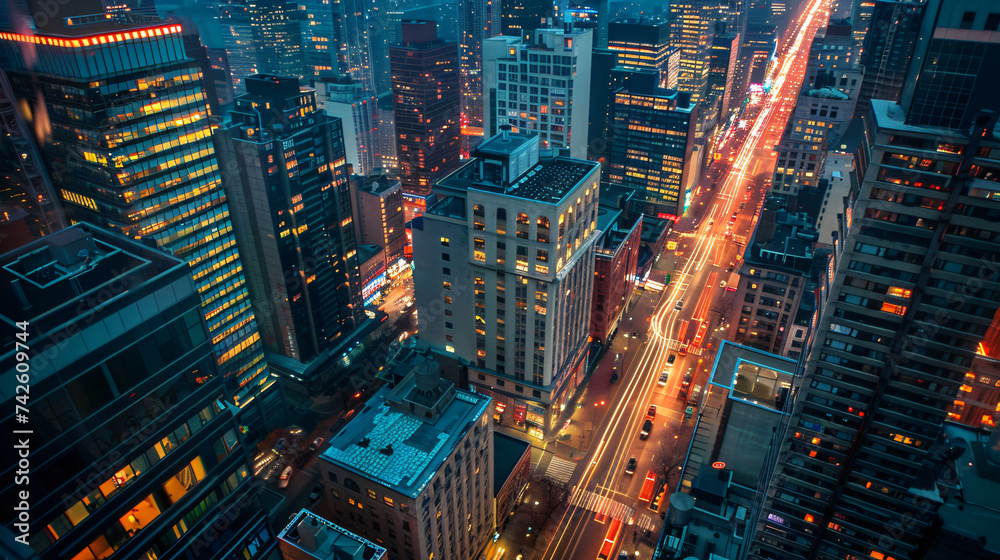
[483,23,594,159]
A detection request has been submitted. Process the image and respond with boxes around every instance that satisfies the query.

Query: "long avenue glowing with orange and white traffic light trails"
[525,0,826,559]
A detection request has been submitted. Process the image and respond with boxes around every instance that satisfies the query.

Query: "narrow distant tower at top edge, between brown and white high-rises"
[458,0,501,152]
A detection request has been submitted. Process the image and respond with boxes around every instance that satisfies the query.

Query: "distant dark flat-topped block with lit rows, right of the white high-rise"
[607,19,670,87]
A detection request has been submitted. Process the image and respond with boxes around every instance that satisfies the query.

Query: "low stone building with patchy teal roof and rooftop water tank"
[318,355,495,560]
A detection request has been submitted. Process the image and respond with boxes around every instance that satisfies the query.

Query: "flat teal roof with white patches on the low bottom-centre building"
[320,376,490,498]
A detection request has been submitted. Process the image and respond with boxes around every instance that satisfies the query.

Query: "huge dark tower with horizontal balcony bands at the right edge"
[751,105,1000,560]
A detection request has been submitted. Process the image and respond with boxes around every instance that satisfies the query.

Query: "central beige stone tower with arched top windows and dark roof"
[413,131,600,436]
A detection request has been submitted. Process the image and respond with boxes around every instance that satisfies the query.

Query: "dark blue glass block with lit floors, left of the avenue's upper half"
[606,80,698,219]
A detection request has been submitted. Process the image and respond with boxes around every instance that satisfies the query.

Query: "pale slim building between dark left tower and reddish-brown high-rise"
[314,75,382,175]
